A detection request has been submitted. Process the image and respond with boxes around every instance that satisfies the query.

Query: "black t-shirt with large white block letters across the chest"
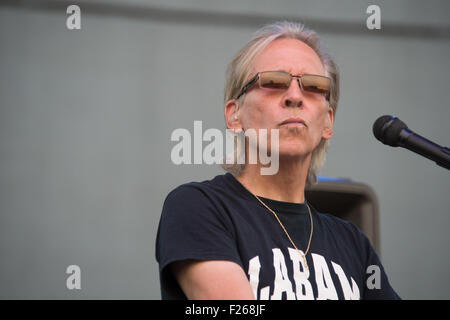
[156,173,399,300]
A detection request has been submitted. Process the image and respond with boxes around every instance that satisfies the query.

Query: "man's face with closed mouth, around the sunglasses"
[239,39,333,158]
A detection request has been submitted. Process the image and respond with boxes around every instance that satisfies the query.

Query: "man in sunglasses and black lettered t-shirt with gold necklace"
[156,22,398,300]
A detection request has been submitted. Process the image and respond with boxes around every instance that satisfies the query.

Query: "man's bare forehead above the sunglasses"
[251,39,325,75]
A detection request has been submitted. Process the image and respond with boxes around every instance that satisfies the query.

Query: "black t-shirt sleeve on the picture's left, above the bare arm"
[156,185,242,273]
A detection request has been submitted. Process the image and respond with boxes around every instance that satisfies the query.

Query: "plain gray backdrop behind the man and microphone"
[0,0,450,299]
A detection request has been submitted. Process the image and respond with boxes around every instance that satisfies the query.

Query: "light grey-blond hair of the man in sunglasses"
[222,21,339,185]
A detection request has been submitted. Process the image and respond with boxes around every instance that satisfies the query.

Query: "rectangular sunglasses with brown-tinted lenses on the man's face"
[236,71,331,101]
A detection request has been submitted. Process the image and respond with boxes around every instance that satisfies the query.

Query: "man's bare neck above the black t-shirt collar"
[236,156,311,203]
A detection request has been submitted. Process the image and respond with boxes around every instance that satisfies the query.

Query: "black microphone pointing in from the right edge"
[372,115,450,170]
